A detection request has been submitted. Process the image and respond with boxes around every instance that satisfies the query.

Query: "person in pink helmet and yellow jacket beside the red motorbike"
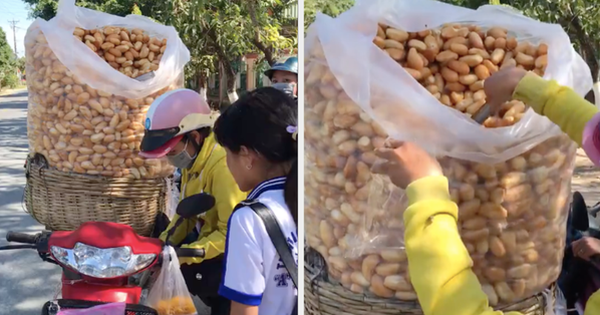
[140,89,246,315]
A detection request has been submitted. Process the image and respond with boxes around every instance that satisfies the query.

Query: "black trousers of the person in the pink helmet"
[153,214,231,315]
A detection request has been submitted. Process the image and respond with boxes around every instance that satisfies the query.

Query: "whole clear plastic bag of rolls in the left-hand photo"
[25,0,190,178]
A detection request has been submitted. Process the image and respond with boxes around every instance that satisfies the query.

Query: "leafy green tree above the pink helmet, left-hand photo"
[169,0,297,102]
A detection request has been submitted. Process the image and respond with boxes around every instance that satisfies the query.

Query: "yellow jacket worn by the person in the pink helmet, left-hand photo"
[160,133,246,264]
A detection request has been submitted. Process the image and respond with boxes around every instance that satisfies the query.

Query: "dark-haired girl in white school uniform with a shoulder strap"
[214,87,298,315]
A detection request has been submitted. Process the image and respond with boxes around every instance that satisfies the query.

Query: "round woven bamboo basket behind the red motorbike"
[24,155,170,236]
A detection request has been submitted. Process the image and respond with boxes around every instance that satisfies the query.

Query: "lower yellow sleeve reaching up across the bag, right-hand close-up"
[404,176,521,315]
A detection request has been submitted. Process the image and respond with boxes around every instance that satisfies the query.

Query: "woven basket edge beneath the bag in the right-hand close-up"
[304,249,556,315]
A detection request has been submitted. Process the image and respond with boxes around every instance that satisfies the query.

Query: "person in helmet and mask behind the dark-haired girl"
[265,56,298,99]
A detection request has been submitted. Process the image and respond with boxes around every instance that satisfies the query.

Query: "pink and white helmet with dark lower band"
[140,89,218,159]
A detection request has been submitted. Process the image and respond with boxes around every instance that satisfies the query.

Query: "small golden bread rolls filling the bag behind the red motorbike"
[26,26,182,179]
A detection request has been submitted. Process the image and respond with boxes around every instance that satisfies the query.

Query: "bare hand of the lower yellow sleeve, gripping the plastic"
[371,140,443,189]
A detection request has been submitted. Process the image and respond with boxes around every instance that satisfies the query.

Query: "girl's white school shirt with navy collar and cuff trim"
[219,177,298,315]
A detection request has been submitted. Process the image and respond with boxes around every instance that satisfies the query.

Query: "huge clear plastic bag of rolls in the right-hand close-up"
[305,0,592,305]
